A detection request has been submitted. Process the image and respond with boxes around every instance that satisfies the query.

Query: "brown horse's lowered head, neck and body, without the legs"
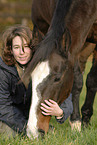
[22,0,97,137]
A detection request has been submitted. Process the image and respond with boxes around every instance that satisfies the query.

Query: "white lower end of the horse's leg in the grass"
[69,120,81,132]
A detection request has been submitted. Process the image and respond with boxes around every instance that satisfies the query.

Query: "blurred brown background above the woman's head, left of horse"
[0,0,33,47]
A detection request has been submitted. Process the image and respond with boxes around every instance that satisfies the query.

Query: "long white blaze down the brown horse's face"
[27,61,50,138]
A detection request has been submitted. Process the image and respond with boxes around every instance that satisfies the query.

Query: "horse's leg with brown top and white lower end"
[70,43,96,130]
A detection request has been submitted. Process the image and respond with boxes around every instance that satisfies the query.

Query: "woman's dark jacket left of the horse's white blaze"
[0,58,31,132]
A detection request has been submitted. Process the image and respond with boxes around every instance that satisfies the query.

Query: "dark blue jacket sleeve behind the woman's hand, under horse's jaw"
[55,94,73,124]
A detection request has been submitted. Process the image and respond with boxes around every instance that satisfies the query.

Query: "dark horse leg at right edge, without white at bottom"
[81,46,97,126]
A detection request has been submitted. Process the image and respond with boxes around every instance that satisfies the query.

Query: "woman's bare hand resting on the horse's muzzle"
[40,99,63,119]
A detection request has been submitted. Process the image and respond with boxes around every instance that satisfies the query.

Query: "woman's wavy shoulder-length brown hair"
[2,25,32,65]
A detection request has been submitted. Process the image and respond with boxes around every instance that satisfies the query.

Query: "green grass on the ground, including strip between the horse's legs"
[0,57,97,145]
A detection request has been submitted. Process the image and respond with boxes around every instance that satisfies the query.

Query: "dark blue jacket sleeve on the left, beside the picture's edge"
[0,70,27,133]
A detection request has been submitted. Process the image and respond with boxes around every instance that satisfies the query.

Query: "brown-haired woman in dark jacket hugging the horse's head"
[0,25,73,136]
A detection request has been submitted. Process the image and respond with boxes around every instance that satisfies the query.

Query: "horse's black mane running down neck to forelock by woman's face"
[22,0,72,84]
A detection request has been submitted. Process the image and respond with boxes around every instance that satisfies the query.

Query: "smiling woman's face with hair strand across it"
[12,36,32,65]
